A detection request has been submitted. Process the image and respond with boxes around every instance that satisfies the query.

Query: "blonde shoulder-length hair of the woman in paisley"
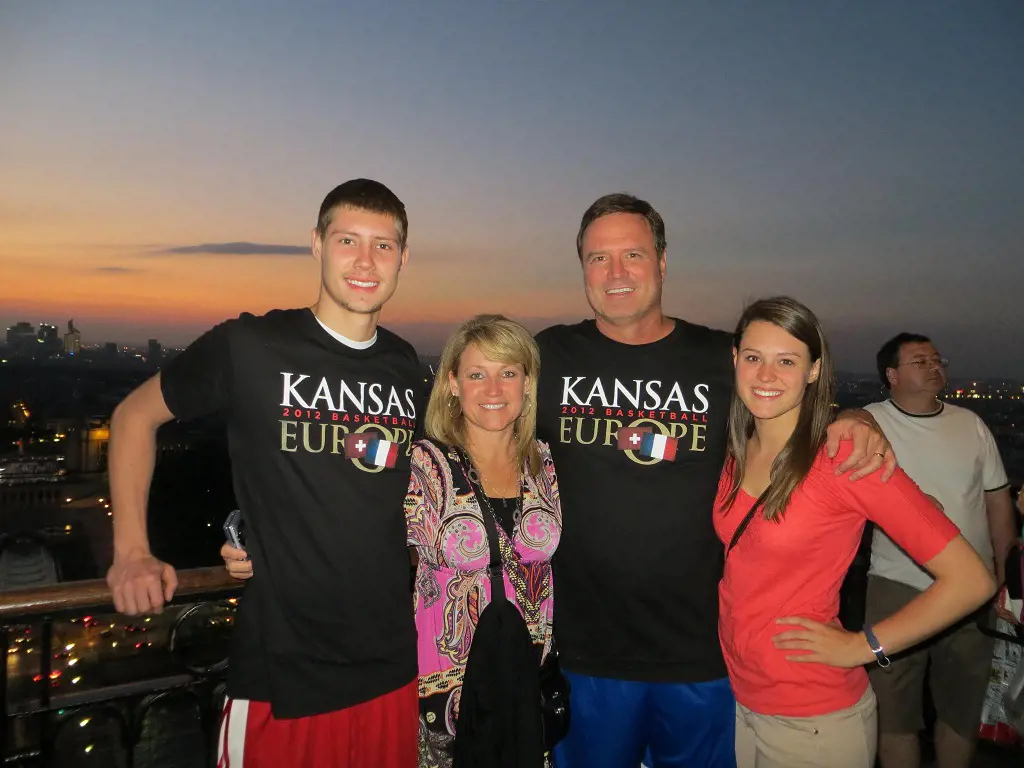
[425,314,541,475]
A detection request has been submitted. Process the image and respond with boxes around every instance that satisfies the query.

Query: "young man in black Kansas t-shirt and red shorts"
[108,179,422,768]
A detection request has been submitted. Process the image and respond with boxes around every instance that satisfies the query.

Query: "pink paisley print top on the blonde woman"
[406,440,562,768]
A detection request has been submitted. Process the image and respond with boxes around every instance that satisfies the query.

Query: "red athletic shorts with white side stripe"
[217,680,419,768]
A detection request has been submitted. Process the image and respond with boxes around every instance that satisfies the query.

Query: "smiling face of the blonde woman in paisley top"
[449,344,529,432]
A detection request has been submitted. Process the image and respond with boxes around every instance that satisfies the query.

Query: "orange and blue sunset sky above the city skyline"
[0,0,1024,377]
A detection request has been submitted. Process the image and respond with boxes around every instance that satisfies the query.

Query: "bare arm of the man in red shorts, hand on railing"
[106,374,178,615]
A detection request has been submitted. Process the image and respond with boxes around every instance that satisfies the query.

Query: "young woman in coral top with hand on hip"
[715,298,994,768]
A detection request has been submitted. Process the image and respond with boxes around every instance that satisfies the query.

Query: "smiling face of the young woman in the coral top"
[732,321,821,425]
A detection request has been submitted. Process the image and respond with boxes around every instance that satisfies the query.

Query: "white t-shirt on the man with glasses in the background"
[866,400,1008,590]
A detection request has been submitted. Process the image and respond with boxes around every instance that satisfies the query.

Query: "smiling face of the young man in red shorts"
[312,206,409,314]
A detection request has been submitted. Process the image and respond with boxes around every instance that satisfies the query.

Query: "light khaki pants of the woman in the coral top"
[736,686,879,768]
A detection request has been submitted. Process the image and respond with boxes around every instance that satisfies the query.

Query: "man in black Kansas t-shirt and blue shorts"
[537,195,895,768]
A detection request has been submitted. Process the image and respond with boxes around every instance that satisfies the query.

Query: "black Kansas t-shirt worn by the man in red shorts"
[161,309,422,718]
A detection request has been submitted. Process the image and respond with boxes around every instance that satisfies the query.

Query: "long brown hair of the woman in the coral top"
[725,296,836,520]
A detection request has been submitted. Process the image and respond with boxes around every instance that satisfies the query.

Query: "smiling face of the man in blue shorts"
[580,213,666,326]
